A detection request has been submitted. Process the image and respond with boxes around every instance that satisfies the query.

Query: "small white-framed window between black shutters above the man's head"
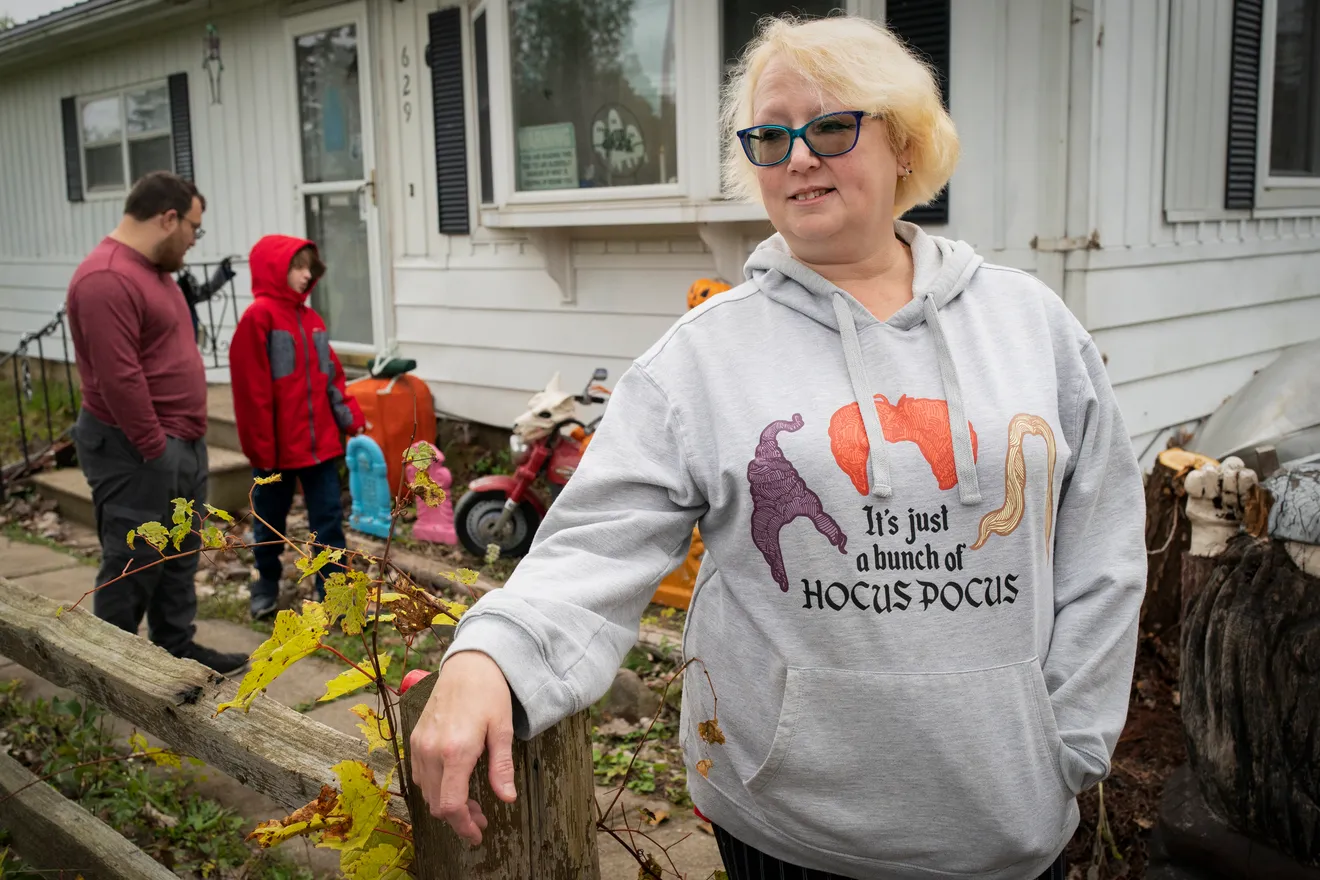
[79,83,174,193]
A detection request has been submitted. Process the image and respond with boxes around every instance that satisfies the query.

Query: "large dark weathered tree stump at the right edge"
[1181,534,1320,865]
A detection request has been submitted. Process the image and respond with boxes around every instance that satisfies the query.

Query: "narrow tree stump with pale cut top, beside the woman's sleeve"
[1140,449,1210,635]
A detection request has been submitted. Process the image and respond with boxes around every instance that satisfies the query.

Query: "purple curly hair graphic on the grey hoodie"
[747,413,847,592]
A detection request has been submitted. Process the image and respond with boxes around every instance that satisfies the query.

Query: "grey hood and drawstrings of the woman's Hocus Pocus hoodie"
[743,220,982,505]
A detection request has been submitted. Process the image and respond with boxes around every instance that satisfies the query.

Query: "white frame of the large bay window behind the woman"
[470,0,884,227]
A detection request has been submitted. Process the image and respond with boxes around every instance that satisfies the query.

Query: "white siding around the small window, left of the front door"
[0,4,301,351]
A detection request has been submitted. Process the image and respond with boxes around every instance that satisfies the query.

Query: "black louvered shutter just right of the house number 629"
[426,7,470,235]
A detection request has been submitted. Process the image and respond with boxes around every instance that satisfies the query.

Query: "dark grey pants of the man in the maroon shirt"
[74,410,207,656]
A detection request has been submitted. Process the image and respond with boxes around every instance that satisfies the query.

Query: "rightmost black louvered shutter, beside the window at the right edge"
[1224,0,1265,210]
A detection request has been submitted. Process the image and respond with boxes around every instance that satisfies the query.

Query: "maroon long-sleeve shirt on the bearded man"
[69,237,206,459]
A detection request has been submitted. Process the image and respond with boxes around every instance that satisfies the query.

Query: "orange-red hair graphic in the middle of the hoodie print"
[829,394,977,495]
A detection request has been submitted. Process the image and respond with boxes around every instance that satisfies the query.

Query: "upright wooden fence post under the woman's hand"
[390,673,601,880]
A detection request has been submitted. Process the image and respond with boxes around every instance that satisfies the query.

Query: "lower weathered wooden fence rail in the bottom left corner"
[0,752,177,880]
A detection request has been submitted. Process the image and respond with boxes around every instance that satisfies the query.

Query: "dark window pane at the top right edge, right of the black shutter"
[1270,0,1320,177]
